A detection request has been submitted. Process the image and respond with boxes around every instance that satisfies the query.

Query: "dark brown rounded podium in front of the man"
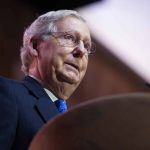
[29,93,150,150]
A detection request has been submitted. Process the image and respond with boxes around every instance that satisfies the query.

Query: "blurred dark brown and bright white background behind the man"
[0,0,150,107]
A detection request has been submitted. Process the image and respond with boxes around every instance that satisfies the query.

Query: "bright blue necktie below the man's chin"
[55,99,67,113]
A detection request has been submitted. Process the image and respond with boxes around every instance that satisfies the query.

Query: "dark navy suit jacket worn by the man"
[0,76,59,150]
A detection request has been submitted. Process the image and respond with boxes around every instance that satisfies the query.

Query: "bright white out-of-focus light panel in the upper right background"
[78,0,150,82]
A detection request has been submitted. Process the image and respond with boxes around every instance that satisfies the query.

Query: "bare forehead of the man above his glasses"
[56,17,90,39]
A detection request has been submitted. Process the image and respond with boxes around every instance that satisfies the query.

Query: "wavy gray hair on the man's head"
[20,10,85,74]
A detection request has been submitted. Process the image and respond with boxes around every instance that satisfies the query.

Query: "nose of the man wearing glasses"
[72,41,87,57]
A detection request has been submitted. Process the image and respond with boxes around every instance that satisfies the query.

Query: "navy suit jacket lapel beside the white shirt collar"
[23,76,59,122]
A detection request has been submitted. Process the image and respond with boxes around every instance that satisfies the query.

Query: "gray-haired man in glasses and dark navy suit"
[0,10,95,150]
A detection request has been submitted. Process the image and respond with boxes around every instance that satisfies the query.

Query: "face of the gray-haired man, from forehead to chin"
[37,17,91,97]
